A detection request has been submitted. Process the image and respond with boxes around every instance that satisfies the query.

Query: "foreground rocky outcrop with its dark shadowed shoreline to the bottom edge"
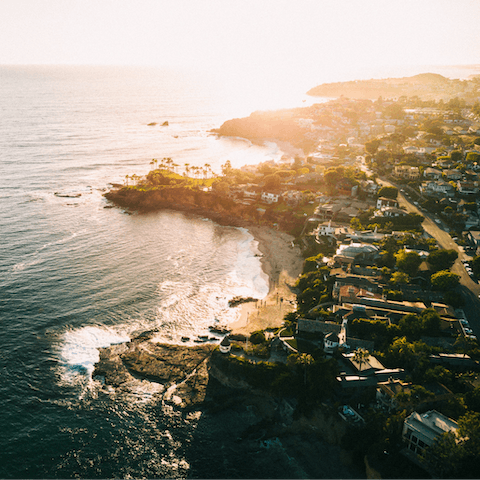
[93,332,365,479]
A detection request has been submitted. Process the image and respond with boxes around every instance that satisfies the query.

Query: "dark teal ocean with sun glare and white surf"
[0,66,478,479]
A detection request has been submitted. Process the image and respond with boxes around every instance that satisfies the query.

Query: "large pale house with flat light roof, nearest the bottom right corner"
[402,410,458,455]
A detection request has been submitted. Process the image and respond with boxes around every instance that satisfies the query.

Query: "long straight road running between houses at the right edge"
[362,161,480,338]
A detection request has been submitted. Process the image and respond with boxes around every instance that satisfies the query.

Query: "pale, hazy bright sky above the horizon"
[0,0,480,86]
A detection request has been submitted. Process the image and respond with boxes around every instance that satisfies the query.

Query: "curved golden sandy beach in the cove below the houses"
[230,226,304,334]
